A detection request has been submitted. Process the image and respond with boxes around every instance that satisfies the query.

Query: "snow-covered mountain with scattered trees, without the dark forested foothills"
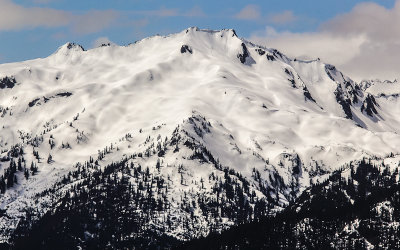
[0,28,400,246]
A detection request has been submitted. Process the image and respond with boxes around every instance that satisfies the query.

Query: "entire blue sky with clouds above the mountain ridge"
[0,0,400,81]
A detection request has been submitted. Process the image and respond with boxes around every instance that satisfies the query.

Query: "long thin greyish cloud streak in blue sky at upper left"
[0,0,205,36]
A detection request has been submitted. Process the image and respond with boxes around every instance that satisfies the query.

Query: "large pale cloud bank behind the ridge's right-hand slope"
[249,0,400,80]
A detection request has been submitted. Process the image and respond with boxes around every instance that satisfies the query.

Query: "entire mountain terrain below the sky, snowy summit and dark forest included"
[0,28,400,249]
